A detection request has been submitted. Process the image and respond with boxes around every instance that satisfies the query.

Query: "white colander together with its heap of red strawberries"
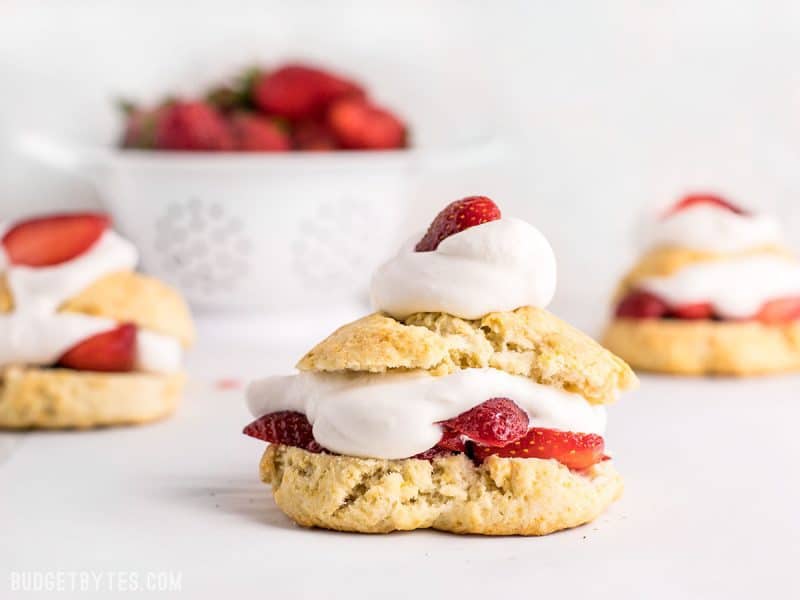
[39,63,496,312]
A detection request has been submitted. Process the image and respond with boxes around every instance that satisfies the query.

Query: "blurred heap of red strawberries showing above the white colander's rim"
[120,64,408,152]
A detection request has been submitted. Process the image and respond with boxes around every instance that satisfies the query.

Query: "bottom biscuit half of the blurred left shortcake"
[0,367,185,429]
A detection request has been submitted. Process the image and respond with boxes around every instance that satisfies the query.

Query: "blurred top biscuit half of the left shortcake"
[0,271,194,346]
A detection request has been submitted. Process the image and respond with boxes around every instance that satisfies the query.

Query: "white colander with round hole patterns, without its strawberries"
[15,136,496,312]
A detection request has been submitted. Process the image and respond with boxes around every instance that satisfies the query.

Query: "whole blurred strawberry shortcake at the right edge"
[604,194,800,375]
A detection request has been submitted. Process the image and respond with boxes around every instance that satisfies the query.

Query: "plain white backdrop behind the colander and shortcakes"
[0,0,800,312]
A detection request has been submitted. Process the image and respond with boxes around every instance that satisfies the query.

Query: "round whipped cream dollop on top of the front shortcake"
[370,218,556,319]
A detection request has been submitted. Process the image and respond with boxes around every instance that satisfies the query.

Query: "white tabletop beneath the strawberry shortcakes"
[0,315,800,600]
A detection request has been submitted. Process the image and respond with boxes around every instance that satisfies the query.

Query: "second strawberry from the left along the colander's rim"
[155,101,233,151]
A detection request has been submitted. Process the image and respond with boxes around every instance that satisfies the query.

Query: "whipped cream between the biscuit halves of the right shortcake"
[636,254,800,319]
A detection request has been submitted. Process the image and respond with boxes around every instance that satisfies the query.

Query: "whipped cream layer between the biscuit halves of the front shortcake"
[247,368,606,459]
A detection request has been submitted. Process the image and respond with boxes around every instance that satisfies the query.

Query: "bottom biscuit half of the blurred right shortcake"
[603,319,800,376]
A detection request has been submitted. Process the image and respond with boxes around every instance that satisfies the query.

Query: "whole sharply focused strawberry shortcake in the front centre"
[245,197,635,535]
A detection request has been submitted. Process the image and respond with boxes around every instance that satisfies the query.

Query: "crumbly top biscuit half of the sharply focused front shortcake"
[297,307,636,404]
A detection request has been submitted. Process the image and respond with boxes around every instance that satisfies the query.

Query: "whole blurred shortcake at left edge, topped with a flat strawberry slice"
[0,214,194,428]
